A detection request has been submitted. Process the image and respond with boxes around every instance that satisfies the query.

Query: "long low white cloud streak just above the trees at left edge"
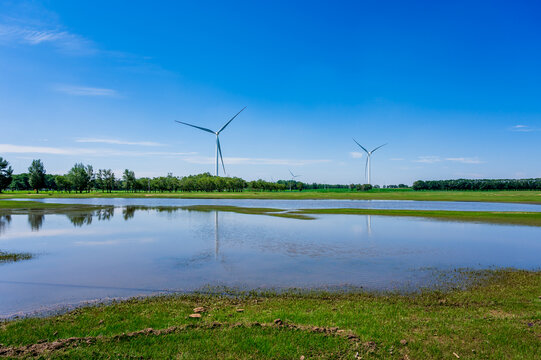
[0,144,193,156]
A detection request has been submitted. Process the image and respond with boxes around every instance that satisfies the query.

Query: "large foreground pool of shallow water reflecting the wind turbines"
[0,205,541,317]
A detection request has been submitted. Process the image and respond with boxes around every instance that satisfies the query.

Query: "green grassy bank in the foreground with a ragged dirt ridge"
[0,271,541,359]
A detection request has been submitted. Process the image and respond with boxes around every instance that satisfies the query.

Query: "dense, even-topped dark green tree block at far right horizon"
[413,178,541,191]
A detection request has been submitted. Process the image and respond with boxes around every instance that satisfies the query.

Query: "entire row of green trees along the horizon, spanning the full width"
[7,157,541,193]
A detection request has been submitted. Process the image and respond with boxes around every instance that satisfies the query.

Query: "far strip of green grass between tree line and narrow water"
[0,189,541,204]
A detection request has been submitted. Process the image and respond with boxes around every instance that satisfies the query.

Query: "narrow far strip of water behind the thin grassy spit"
[7,198,541,212]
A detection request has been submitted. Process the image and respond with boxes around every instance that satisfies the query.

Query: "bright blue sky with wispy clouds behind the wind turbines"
[0,1,541,185]
